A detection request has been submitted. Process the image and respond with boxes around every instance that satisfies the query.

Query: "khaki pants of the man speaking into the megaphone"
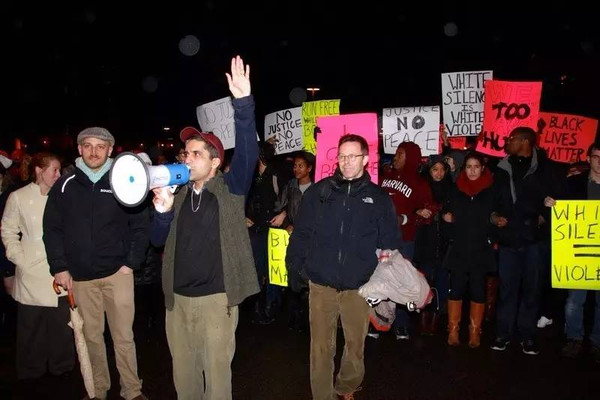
[166,293,238,400]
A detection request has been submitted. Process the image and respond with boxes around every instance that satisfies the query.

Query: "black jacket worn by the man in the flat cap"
[44,168,149,281]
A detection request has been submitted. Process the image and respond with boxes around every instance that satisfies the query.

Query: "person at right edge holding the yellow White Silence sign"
[544,142,600,363]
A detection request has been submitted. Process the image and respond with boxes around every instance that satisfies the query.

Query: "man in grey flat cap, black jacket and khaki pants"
[43,127,149,400]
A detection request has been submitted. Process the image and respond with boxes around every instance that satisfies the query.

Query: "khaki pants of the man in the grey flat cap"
[73,272,142,400]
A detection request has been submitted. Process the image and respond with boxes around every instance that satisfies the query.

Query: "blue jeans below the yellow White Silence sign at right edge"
[565,290,600,347]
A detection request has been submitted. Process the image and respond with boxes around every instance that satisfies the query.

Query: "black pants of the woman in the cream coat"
[16,297,75,379]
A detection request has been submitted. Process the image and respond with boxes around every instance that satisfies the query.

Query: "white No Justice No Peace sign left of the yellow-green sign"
[265,107,304,154]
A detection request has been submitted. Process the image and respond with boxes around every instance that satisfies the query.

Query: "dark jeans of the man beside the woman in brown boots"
[496,243,545,340]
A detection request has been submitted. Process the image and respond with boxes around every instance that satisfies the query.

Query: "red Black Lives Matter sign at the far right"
[539,112,598,163]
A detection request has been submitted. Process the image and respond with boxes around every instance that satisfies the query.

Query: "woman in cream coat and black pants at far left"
[1,153,75,379]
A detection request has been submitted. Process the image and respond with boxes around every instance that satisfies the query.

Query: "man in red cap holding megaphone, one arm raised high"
[150,56,259,400]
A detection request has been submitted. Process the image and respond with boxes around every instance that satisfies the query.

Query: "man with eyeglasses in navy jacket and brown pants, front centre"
[286,135,400,400]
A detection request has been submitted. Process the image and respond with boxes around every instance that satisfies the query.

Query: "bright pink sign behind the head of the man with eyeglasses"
[315,113,379,184]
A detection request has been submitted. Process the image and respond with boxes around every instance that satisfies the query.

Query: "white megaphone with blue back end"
[109,152,190,207]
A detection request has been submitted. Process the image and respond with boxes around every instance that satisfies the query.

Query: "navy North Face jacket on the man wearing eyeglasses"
[286,169,400,290]
